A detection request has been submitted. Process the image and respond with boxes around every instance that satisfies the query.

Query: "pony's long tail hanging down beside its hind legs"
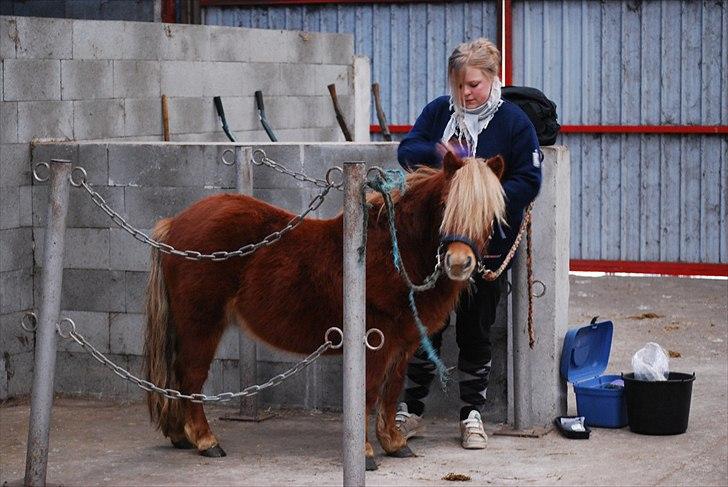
[144,218,181,436]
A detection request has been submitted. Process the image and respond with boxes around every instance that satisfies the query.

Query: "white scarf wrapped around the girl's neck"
[442,76,503,156]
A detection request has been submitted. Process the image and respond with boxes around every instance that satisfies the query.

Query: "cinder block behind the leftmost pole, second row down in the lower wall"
[33,186,123,228]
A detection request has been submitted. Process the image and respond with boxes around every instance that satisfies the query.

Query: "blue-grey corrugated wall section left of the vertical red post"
[205,1,497,124]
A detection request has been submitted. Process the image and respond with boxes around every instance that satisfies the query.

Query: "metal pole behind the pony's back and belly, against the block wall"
[235,147,258,419]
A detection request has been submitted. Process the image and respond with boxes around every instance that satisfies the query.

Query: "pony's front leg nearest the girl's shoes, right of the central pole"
[377,353,416,458]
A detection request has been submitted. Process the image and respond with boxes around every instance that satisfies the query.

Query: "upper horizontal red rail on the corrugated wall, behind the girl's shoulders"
[369,125,728,135]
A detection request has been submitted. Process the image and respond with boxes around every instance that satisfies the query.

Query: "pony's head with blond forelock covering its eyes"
[440,152,506,281]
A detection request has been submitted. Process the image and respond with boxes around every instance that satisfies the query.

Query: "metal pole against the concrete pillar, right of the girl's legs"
[511,239,533,430]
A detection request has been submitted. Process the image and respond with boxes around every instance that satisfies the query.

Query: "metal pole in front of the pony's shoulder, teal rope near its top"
[343,162,366,487]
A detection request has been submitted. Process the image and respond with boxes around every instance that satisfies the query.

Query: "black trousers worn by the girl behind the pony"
[404,275,502,420]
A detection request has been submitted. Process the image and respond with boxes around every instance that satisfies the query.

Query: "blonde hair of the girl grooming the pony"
[447,37,501,105]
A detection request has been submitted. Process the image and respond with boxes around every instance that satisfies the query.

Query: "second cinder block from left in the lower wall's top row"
[109,144,205,187]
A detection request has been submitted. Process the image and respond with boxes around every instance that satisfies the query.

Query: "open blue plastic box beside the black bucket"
[561,319,627,428]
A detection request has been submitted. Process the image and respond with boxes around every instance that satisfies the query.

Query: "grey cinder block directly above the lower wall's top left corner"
[18,101,73,142]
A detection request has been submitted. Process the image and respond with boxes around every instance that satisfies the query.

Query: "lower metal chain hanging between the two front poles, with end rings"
[23,313,342,403]
